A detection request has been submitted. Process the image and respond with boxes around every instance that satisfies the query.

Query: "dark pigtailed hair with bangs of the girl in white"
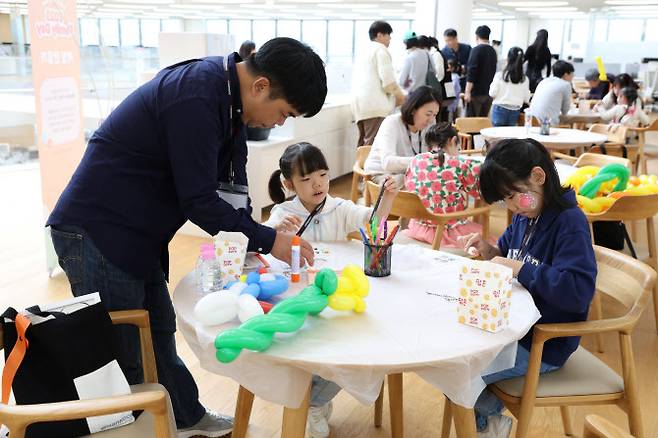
[267,142,329,204]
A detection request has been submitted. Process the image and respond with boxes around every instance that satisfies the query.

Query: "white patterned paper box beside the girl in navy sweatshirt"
[457,261,512,333]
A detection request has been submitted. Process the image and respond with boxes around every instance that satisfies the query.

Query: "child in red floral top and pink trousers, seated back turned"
[403,123,490,248]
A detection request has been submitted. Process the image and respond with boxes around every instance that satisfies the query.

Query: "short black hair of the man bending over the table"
[246,37,327,117]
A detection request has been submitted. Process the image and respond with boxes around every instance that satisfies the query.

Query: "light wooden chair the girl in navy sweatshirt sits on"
[464,246,656,438]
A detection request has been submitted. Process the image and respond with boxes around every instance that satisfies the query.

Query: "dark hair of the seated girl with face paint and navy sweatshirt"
[480,138,573,210]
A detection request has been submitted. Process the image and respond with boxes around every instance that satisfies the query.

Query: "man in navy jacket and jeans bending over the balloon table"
[47,38,327,437]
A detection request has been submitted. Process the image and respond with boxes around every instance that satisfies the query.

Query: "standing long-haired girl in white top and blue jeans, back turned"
[489,47,530,126]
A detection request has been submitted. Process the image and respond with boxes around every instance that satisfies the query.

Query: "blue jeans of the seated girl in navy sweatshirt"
[474,345,560,432]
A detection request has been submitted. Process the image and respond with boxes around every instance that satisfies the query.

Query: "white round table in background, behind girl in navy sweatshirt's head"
[480,126,607,150]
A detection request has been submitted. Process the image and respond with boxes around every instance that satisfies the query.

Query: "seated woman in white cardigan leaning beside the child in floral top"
[364,86,441,186]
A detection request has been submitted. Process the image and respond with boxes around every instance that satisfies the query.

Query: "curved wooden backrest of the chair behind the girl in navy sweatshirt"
[594,245,656,314]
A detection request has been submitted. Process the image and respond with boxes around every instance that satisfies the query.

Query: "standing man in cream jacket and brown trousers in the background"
[351,21,404,146]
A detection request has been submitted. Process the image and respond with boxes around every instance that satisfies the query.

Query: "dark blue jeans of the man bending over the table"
[50,225,205,428]
